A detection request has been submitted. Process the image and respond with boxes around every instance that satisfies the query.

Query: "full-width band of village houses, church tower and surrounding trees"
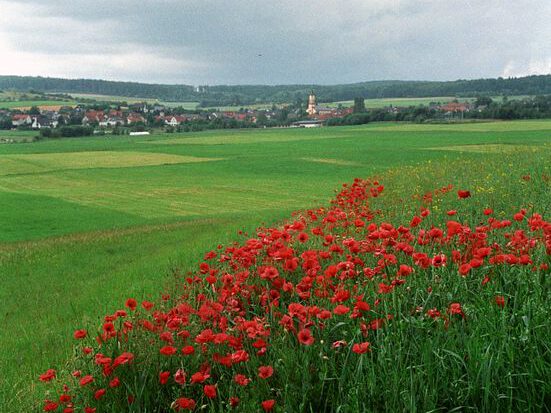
[0,90,551,143]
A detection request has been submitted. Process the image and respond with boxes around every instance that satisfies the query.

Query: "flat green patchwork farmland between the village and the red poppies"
[0,121,551,411]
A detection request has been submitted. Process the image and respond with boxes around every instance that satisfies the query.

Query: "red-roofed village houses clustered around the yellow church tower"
[0,92,475,133]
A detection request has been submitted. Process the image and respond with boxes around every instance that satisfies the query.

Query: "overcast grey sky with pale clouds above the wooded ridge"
[0,0,551,85]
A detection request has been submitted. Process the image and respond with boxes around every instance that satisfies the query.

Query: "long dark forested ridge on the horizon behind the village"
[0,75,551,106]
